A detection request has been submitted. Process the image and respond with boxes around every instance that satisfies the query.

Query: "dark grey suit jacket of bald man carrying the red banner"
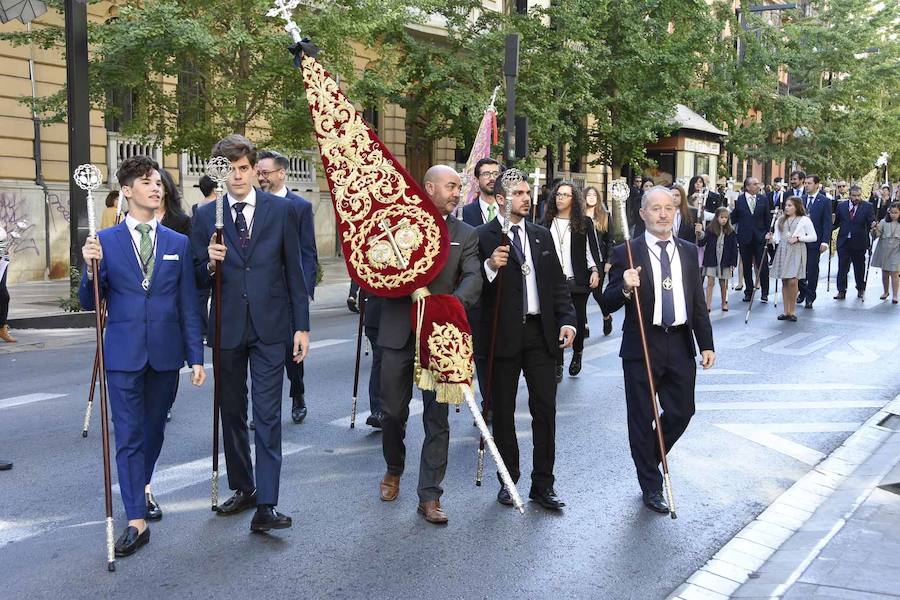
[378,215,481,350]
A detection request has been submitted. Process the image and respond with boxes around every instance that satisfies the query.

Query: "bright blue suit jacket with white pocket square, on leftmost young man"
[78,222,203,371]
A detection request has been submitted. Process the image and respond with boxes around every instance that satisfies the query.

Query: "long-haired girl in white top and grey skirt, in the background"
[766,196,818,322]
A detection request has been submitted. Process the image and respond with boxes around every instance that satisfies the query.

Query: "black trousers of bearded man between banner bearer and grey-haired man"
[492,317,558,491]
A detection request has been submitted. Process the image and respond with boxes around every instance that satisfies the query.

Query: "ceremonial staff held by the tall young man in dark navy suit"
[206,156,233,510]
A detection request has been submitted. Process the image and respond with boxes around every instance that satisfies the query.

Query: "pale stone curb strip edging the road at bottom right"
[667,395,900,600]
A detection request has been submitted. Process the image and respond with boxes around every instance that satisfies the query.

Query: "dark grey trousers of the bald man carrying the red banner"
[381,336,450,502]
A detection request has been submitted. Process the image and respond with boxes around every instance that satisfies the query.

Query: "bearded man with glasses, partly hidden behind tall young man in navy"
[256,150,319,423]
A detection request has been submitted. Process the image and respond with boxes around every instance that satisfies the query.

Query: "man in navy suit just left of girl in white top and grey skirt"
[731,177,775,302]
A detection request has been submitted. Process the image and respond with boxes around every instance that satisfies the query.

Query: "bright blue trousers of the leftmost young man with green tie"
[106,365,178,520]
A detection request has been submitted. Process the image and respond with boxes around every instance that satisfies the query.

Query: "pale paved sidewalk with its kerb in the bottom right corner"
[670,396,900,600]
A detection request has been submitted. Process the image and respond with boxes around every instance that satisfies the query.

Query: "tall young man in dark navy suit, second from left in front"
[191,134,309,531]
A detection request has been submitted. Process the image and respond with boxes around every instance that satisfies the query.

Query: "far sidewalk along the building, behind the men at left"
[9,258,350,330]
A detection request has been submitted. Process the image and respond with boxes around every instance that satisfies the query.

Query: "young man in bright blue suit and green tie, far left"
[78,156,206,556]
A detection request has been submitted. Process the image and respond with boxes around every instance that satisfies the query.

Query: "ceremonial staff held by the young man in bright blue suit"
[73,163,116,571]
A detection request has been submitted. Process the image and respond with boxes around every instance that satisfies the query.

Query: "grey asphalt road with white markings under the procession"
[0,269,900,599]
